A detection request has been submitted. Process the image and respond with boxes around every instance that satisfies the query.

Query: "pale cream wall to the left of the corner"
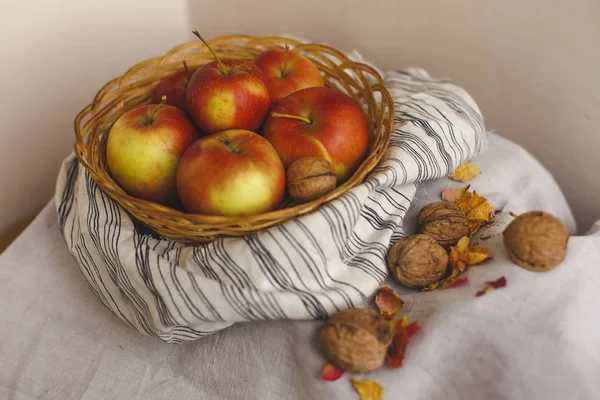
[0,0,192,247]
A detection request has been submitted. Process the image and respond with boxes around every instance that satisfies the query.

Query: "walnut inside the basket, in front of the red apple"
[287,157,337,203]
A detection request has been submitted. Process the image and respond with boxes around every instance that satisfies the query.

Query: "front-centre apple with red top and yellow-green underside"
[177,129,285,215]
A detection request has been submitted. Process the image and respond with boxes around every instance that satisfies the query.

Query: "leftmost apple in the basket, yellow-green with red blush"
[106,96,198,205]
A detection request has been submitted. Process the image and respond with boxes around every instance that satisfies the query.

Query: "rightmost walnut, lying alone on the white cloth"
[502,211,569,271]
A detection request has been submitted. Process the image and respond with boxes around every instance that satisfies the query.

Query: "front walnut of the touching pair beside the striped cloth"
[387,234,448,288]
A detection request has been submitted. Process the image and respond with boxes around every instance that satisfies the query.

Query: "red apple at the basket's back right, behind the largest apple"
[254,46,324,104]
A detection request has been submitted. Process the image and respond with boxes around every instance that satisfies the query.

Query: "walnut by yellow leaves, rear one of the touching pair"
[418,201,469,248]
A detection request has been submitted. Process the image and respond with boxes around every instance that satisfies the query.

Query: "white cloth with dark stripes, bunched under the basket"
[55,65,486,343]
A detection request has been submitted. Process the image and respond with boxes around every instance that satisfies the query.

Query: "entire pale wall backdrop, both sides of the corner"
[0,0,600,248]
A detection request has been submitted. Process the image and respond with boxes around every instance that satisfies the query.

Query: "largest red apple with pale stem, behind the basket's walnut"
[262,87,369,182]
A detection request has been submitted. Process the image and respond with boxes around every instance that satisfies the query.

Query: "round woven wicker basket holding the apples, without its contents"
[75,36,394,243]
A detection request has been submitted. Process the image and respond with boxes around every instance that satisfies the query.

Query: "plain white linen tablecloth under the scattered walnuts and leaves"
[0,134,600,400]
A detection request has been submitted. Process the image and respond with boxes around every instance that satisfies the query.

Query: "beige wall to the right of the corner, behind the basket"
[190,0,600,229]
